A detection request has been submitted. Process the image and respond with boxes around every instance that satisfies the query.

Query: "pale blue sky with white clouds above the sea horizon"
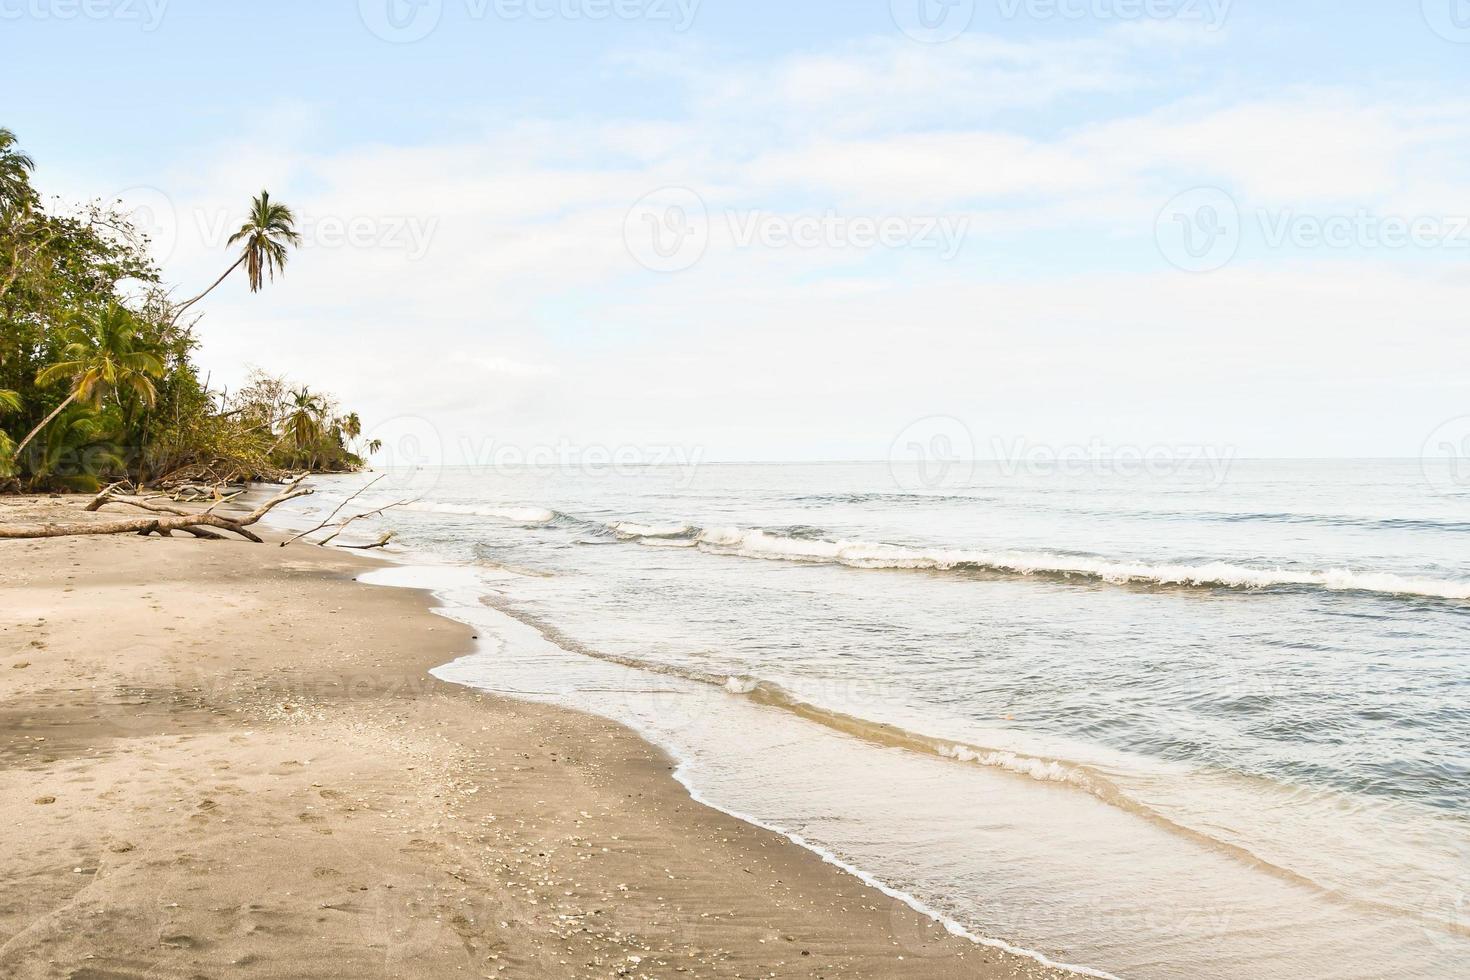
[0,0,1470,463]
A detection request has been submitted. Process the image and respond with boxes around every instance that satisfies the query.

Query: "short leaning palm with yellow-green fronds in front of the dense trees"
[10,303,163,461]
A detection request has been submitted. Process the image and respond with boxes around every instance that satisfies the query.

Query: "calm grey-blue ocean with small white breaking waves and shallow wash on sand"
[270,458,1470,979]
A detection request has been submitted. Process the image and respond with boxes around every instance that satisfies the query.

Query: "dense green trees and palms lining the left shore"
[0,128,373,491]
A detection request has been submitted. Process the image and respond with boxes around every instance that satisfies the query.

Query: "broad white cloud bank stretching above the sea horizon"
[71,31,1470,458]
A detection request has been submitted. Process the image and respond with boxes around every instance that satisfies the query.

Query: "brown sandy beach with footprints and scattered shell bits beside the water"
[0,498,1081,980]
